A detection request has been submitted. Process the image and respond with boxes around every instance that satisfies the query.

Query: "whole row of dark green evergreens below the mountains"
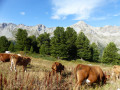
[0,27,120,64]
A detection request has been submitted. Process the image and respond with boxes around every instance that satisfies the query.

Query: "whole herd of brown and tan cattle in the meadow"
[0,53,120,87]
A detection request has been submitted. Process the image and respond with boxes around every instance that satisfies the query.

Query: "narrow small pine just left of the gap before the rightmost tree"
[91,43,100,62]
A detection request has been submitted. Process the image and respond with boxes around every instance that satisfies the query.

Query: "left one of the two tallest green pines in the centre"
[51,27,67,59]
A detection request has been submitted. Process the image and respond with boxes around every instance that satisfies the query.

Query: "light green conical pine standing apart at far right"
[102,42,119,64]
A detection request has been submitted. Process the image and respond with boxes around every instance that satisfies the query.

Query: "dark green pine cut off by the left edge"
[0,36,9,52]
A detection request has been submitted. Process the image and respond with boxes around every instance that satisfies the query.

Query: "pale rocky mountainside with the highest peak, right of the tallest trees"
[70,21,120,48]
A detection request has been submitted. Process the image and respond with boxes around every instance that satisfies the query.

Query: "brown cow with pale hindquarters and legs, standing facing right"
[10,55,31,72]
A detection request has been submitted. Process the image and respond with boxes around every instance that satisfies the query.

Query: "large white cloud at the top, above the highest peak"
[51,0,116,20]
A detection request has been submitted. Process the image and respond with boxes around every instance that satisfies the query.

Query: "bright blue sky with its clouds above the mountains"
[0,0,120,27]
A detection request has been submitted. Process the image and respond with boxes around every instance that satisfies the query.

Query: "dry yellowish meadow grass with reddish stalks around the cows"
[0,57,120,90]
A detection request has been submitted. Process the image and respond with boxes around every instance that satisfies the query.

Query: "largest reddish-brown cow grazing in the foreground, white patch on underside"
[75,64,107,87]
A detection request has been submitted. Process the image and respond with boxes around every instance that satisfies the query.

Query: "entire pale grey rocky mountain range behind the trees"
[0,21,120,48]
